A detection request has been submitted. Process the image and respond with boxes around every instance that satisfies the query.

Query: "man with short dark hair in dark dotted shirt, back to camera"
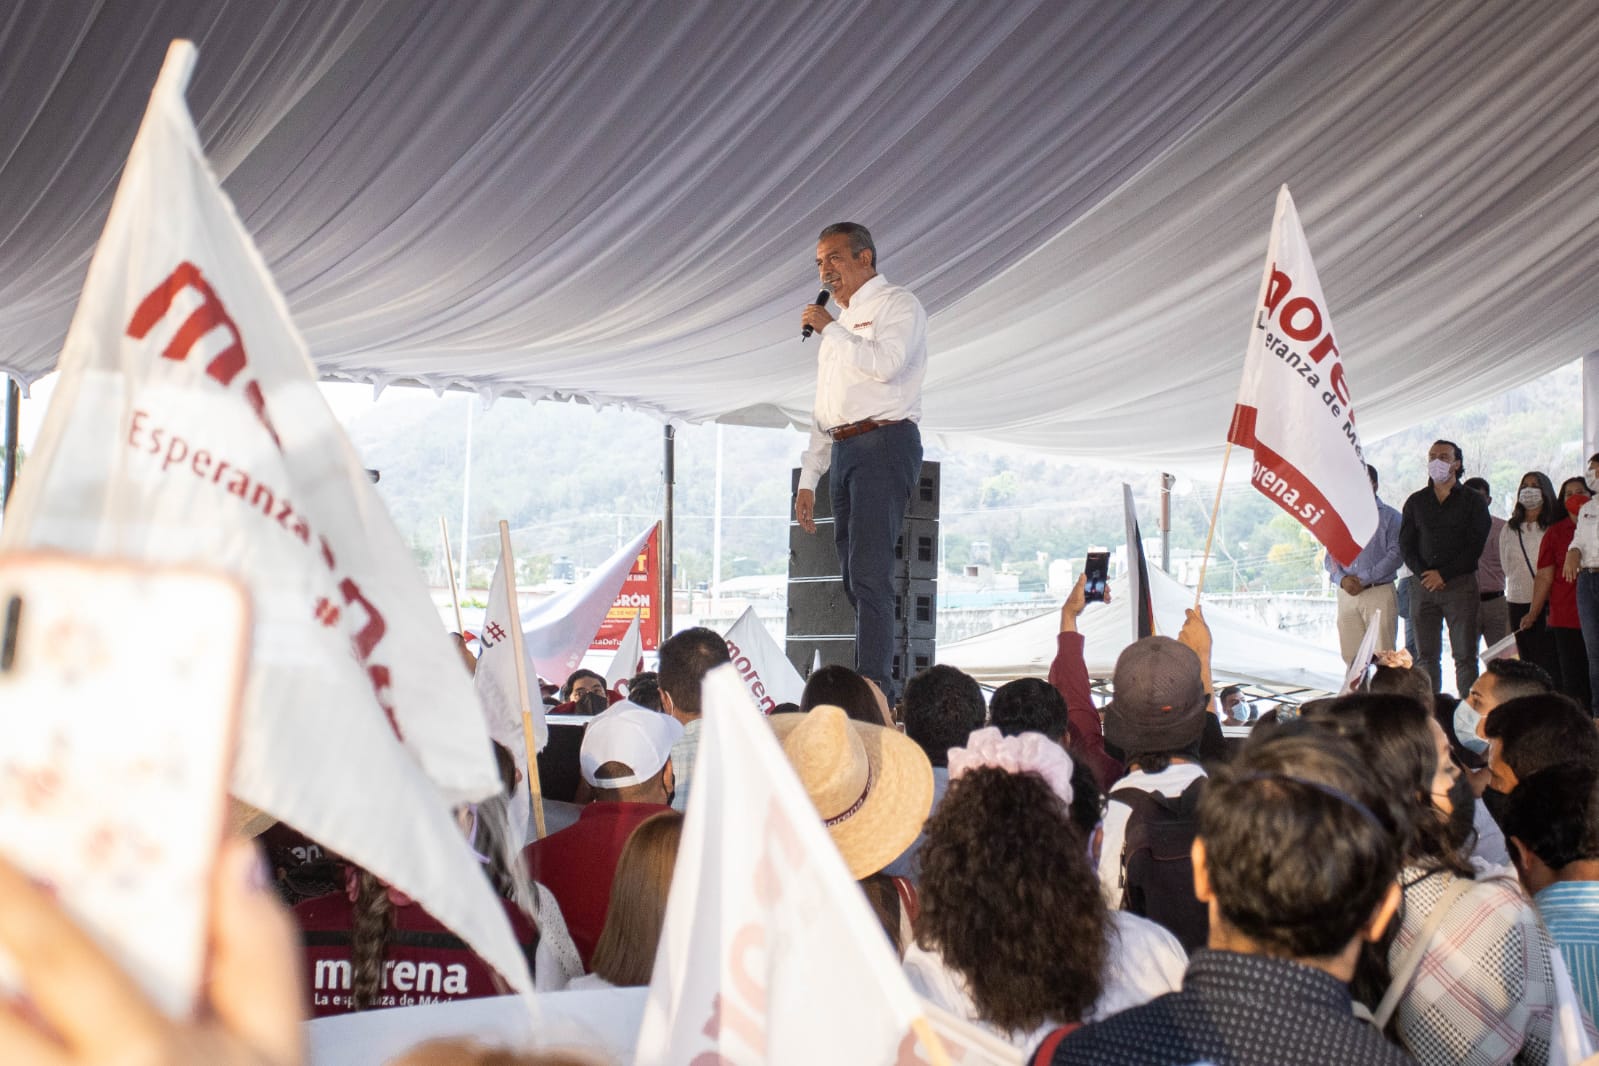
[1039,727,1412,1066]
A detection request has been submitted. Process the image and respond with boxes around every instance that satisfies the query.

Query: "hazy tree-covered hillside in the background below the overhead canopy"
[343,363,1586,593]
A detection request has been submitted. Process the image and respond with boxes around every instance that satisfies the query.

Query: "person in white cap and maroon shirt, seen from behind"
[523,700,683,970]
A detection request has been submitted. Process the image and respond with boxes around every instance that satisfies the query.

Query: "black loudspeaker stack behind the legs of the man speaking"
[785,462,939,687]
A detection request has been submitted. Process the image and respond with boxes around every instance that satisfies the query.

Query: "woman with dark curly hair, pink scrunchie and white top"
[905,727,1186,1048]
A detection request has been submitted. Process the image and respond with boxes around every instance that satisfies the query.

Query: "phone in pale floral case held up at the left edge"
[0,553,249,1016]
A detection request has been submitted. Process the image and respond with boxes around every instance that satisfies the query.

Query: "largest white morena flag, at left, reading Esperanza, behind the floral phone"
[0,42,531,991]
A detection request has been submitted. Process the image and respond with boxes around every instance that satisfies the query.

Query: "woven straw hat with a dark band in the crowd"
[766,703,932,881]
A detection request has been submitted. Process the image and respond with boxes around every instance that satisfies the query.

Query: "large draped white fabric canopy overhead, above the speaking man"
[0,0,1599,467]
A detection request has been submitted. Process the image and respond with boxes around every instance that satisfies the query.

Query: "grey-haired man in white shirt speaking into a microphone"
[795,222,927,703]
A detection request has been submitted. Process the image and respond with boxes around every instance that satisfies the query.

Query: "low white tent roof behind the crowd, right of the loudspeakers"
[939,569,1345,692]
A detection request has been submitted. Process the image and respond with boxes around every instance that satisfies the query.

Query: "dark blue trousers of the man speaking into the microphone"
[828,422,921,705]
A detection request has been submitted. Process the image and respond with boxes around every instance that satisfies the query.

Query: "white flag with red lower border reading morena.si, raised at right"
[1226,185,1377,566]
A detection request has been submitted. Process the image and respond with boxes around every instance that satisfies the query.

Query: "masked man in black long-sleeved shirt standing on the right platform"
[1399,441,1492,695]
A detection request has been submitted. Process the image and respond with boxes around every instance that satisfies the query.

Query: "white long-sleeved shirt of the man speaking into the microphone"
[800,273,927,491]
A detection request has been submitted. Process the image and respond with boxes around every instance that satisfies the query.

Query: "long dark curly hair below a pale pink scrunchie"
[916,767,1110,1032]
